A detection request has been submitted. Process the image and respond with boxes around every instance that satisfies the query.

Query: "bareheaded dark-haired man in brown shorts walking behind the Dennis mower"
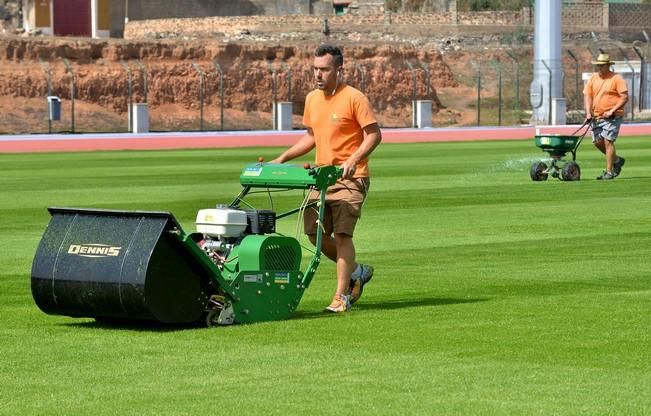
[271,45,382,313]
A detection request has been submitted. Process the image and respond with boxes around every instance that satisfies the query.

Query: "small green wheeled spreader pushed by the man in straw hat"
[530,123,590,181]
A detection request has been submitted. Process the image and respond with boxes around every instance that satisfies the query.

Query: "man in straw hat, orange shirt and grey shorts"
[583,53,628,179]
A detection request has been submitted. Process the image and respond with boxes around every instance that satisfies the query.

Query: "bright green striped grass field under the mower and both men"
[0,137,651,415]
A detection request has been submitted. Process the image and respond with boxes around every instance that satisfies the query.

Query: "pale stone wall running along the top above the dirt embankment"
[114,0,651,39]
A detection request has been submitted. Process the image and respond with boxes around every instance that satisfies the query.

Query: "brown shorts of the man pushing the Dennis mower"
[303,178,371,237]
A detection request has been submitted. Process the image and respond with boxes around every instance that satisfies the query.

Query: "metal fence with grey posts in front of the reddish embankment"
[0,39,651,134]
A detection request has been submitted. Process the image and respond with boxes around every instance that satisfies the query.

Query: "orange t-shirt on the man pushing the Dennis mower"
[303,85,377,178]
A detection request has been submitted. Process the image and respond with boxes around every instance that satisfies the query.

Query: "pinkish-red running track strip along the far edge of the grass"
[0,123,651,153]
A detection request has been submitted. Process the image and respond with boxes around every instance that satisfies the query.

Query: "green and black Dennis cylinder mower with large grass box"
[31,162,341,326]
